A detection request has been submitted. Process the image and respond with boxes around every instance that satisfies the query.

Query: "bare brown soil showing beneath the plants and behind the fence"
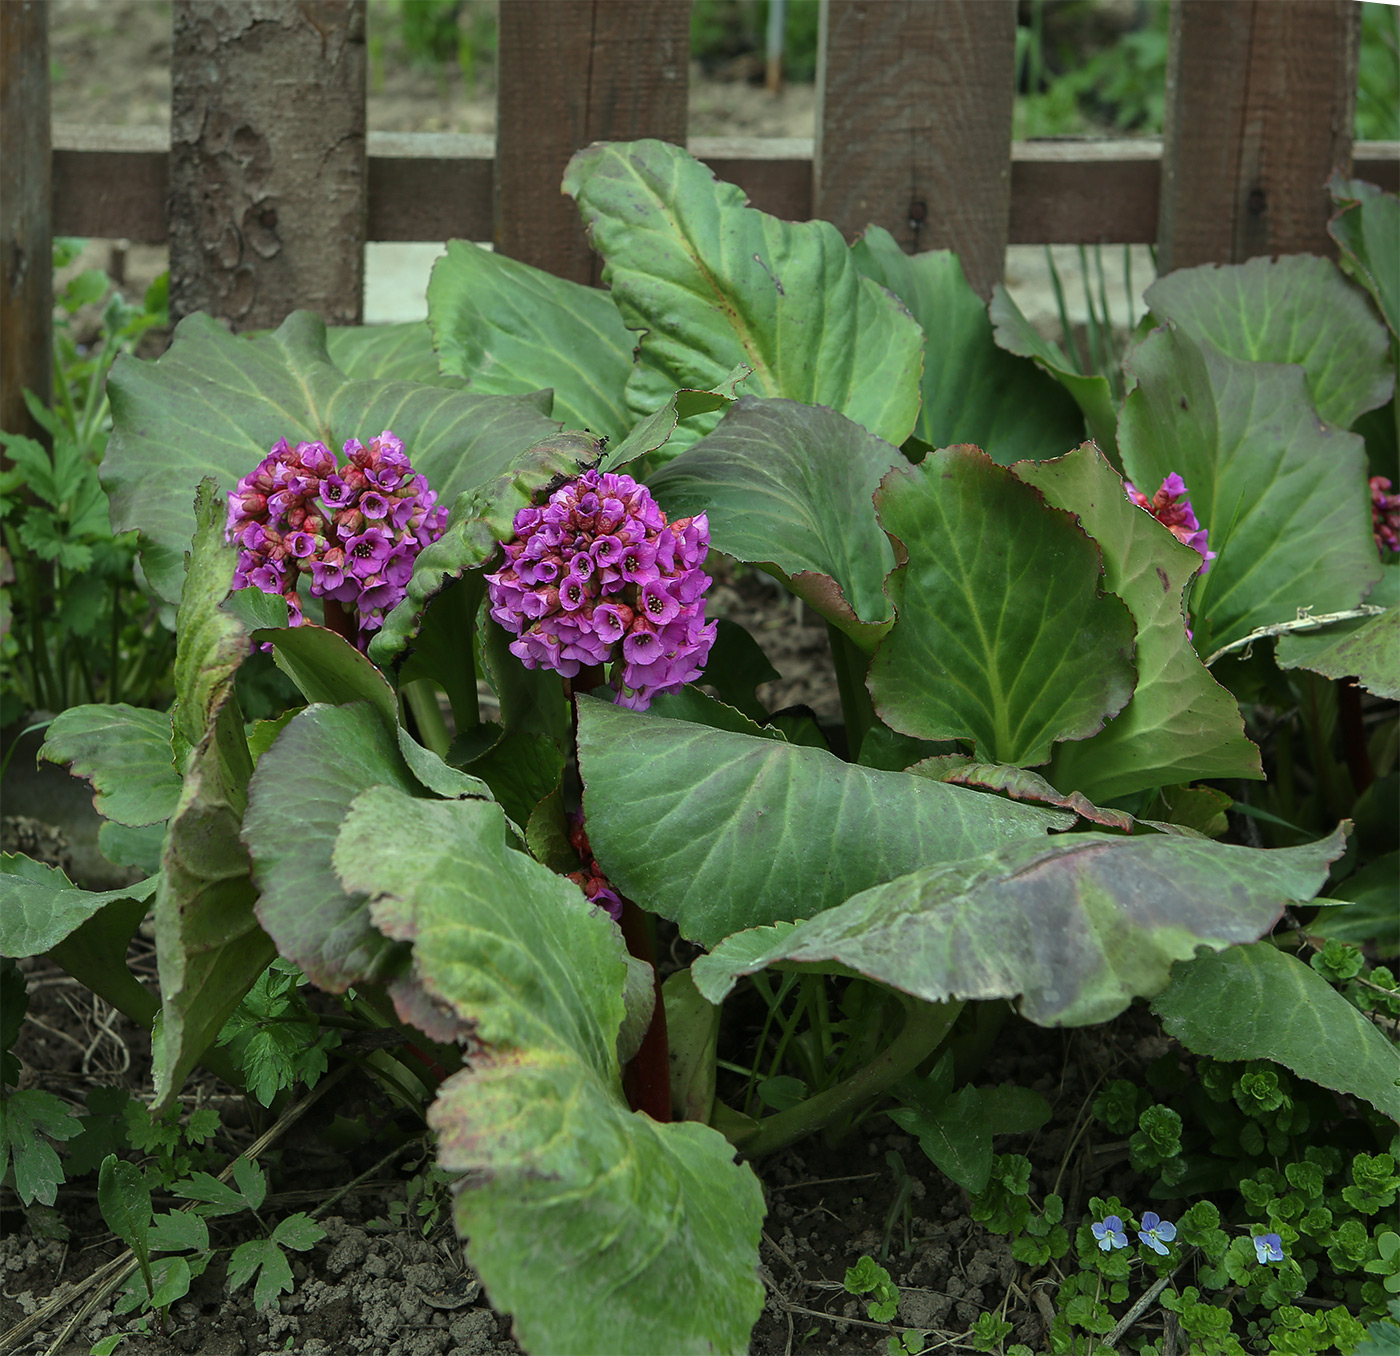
[0,0,1187,1356]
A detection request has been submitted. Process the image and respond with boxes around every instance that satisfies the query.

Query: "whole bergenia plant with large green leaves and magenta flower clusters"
[0,141,1400,1353]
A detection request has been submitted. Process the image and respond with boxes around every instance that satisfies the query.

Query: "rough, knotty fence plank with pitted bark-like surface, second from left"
[171,0,368,330]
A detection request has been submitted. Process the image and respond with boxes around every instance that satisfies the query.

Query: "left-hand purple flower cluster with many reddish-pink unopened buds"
[225,430,447,649]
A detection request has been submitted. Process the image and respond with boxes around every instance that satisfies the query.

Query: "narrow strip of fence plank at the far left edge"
[0,0,53,441]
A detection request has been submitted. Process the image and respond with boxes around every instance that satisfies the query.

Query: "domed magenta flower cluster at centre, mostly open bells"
[486,470,715,711]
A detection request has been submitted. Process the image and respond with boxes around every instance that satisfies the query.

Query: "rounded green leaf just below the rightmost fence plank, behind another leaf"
[1144,255,1394,425]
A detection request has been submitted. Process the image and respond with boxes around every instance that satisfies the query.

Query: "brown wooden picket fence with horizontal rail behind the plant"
[0,0,1400,439]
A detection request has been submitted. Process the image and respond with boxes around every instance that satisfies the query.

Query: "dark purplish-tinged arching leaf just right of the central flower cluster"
[647,396,904,649]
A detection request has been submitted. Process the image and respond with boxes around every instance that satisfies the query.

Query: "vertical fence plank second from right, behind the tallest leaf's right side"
[812,0,1016,297]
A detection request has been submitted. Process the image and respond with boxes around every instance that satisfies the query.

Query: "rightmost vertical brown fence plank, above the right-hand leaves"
[1158,0,1361,271]
